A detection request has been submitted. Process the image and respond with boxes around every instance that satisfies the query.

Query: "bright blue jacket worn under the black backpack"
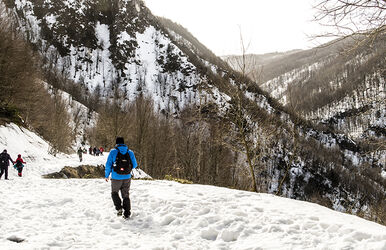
[105,144,137,180]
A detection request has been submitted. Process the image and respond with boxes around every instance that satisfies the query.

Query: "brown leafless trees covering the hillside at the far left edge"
[0,8,74,154]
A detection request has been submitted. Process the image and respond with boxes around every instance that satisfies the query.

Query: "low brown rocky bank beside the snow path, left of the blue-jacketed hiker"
[43,165,105,179]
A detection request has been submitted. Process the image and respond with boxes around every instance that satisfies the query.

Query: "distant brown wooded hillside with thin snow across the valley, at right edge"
[227,37,386,139]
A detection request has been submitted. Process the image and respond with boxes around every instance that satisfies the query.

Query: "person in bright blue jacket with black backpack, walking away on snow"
[105,137,137,219]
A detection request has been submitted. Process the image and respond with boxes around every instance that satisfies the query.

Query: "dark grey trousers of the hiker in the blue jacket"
[111,179,131,217]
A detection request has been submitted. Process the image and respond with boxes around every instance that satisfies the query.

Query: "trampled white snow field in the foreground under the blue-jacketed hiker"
[0,178,386,250]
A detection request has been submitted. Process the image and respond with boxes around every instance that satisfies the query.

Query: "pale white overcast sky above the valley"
[145,0,328,56]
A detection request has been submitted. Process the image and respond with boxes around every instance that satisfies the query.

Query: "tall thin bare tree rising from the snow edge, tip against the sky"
[217,32,279,192]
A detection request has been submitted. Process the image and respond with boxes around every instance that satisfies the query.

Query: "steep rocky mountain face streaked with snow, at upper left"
[6,0,226,113]
